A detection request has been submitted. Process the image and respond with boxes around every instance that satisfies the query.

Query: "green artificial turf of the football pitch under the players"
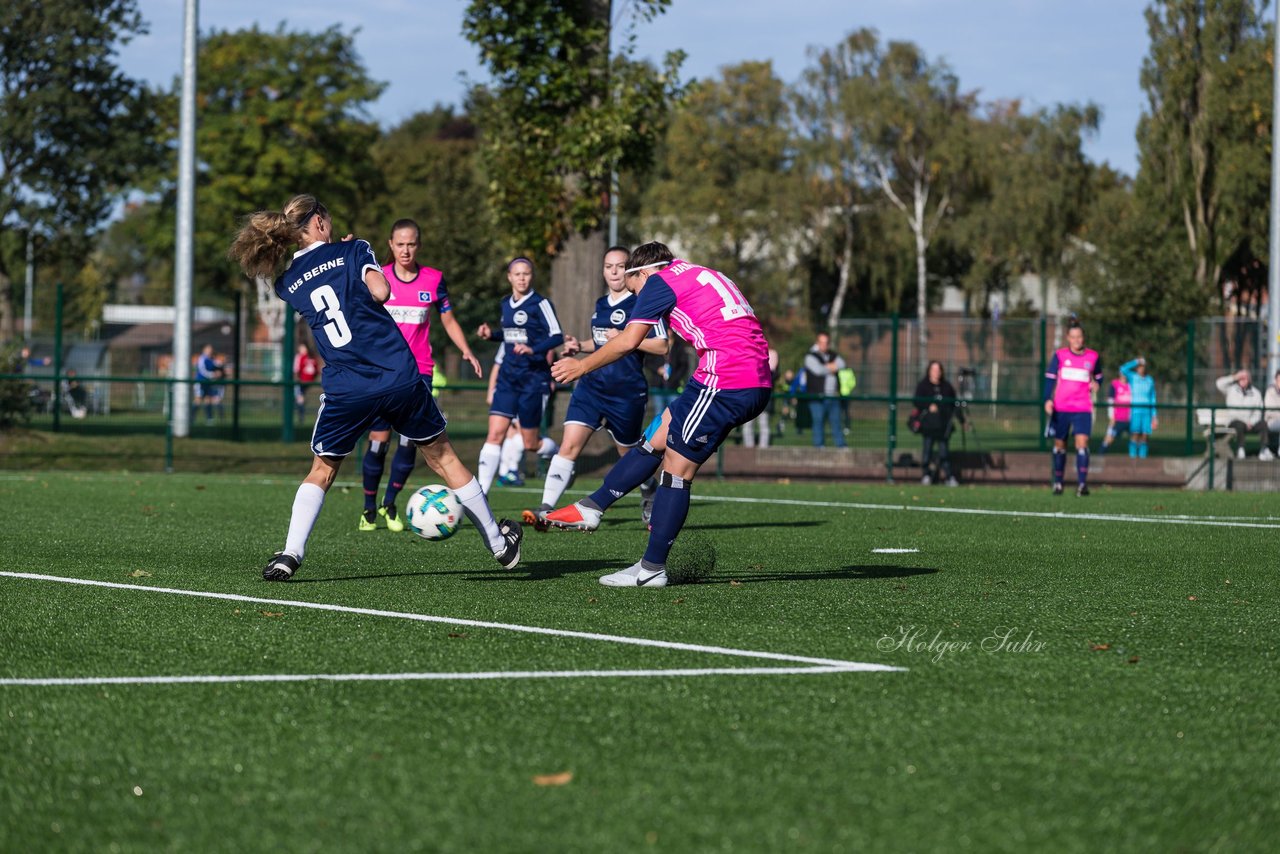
[0,471,1280,851]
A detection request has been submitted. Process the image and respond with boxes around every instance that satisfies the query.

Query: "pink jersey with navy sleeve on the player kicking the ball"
[630,259,773,389]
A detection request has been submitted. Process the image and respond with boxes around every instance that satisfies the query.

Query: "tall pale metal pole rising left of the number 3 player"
[170,0,200,438]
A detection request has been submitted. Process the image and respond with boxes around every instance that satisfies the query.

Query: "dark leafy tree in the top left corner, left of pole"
[0,0,161,338]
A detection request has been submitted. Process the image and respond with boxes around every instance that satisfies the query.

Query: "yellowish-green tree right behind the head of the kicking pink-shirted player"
[644,61,800,323]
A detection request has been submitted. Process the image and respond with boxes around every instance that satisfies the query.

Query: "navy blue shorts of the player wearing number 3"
[311,380,444,457]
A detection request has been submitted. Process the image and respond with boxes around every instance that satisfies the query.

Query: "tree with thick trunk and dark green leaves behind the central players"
[462,0,682,335]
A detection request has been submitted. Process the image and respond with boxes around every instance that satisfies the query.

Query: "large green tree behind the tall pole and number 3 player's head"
[135,24,384,333]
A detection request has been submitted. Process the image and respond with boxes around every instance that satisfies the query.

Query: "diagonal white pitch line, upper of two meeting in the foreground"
[0,571,904,685]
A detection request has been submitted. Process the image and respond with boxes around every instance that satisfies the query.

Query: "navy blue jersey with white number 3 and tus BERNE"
[275,241,421,398]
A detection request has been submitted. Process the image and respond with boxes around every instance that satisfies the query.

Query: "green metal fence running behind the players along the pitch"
[0,295,1280,478]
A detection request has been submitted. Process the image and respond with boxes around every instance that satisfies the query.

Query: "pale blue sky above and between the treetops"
[122,0,1147,174]
